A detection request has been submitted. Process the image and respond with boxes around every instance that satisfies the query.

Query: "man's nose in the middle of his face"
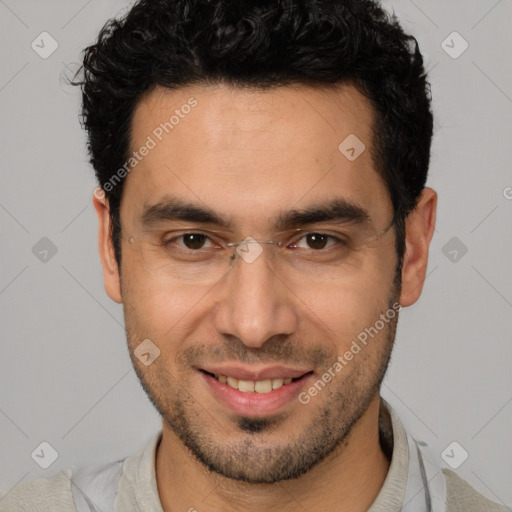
[213,243,298,348]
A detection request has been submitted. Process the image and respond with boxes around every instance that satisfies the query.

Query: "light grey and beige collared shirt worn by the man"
[0,399,510,512]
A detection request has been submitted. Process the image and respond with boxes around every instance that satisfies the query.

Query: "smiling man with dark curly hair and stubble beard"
[0,0,506,512]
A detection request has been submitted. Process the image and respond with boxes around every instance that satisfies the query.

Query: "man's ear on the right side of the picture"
[400,188,437,307]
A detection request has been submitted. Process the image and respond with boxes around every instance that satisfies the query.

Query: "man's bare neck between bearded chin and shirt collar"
[156,395,389,512]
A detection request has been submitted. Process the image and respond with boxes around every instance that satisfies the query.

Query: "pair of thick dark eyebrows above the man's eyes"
[141,197,371,231]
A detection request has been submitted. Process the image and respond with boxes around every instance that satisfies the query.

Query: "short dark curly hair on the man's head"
[74,0,433,273]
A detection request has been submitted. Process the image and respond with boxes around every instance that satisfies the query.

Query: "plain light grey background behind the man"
[0,0,512,505]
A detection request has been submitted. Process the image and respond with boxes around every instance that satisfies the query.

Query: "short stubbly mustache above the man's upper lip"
[179,336,337,367]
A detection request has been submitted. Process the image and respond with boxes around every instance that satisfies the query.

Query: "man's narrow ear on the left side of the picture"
[92,191,123,303]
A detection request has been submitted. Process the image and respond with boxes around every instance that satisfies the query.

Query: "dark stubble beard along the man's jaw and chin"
[127,297,398,484]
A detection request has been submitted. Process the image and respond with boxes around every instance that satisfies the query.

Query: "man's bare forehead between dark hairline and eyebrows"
[121,85,392,232]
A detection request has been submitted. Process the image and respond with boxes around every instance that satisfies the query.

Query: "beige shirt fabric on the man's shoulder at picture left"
[0,468,76,512]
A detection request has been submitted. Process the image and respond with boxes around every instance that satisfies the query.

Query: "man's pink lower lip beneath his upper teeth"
[199,372,312,417]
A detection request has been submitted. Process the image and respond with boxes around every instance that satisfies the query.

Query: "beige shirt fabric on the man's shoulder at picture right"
[443,469,512,512]
